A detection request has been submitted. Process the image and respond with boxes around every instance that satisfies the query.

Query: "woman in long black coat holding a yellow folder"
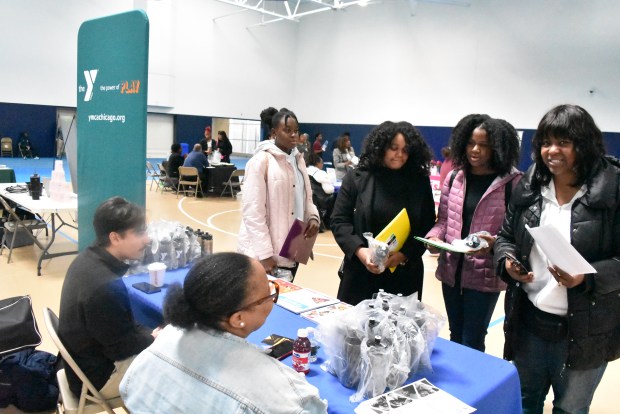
[331,121,435,305]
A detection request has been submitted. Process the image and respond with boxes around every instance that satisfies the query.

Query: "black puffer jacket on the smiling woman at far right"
[495,157,620,369]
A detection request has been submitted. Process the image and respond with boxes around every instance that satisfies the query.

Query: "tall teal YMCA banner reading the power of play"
[77,10,149,250]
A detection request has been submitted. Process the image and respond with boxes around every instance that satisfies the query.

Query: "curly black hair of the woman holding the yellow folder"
[358,121,432,175]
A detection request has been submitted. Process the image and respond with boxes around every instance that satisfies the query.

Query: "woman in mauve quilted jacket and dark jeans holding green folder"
[426,114,521,352]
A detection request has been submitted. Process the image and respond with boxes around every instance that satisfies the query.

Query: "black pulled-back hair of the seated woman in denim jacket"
[164,253,252,330]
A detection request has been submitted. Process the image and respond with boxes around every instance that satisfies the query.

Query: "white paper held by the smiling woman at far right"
[525,224,596,276]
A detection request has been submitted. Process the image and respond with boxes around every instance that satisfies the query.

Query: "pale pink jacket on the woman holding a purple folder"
[237,145,319,267]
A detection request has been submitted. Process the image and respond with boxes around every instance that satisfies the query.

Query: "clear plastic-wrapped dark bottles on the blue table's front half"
[317,292,446,402]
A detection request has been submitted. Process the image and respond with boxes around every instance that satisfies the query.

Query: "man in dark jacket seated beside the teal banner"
[58,197,158,398]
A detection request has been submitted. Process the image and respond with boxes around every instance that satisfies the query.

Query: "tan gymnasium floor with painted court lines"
[0,159,620,414]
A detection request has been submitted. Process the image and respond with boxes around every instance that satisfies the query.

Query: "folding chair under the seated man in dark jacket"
[43,308,124,414]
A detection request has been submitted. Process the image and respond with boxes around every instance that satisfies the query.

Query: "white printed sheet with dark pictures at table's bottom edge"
[355,378,476,414]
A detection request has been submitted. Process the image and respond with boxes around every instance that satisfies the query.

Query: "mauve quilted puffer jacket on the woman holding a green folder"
[426,169,522,292]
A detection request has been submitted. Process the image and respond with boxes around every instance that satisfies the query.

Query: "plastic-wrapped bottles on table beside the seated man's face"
[128,220,202,274]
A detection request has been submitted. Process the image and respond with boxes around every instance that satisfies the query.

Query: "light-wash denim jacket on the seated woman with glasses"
[120,325,327,414]
